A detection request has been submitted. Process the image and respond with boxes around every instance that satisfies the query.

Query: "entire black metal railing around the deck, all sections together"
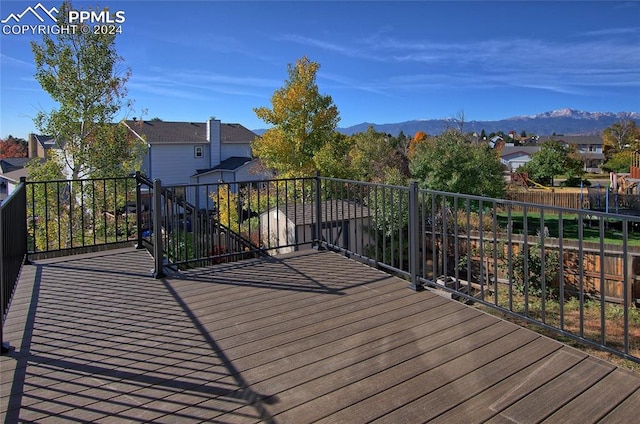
[2,175,640,362]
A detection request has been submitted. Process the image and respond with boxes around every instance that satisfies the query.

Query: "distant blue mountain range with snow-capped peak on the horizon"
[254,108,640,136]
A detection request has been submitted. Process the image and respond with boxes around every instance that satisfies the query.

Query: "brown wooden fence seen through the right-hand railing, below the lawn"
[447,235,640,304]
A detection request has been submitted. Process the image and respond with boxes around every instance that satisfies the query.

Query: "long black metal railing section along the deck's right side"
[321,178,640,362]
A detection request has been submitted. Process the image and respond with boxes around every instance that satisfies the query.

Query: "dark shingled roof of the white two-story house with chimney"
[127,121,257,144]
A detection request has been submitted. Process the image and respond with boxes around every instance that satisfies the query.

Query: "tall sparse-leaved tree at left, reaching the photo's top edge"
[31,1,144,179]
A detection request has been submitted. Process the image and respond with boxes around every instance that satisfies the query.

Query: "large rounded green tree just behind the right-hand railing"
[409,130,505,198]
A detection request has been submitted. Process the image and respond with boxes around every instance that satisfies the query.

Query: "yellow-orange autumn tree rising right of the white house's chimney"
[252,57,342,177]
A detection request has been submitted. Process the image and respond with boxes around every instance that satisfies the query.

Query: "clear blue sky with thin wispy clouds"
[0,0,640,138]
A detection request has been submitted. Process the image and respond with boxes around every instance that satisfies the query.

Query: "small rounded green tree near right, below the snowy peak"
[520,140,584,185]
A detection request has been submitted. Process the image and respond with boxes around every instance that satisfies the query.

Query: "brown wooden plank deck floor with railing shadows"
[0,249,640,424]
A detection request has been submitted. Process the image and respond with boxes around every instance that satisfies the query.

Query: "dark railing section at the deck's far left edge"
[0,181,27,353]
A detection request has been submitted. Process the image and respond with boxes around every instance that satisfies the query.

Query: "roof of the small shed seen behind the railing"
[271,200,370,225]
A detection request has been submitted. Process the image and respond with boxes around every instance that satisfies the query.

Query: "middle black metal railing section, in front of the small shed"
[152,178,316,267]
